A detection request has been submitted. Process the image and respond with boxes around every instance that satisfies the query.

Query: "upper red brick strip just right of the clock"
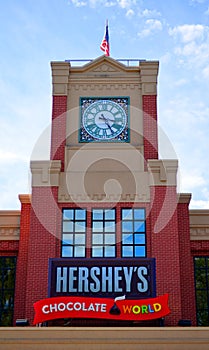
[142,95,158,162]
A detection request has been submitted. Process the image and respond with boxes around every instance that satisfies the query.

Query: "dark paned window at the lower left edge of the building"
[0,257,16,327]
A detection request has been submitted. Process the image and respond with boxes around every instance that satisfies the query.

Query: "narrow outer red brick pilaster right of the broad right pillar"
[178,203,196,326]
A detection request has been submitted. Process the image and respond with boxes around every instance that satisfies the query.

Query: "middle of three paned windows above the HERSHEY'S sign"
[92,209,116,258]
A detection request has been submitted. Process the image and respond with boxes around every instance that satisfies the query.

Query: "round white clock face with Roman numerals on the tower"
[82,99,127,141]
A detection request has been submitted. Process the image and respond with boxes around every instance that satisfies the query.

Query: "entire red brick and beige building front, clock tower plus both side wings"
[0,56,209,326]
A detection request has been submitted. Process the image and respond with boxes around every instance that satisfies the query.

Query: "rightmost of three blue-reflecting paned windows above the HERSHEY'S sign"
[121,208,146,258]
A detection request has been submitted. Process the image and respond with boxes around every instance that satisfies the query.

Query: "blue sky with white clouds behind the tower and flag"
[0,0,209,209]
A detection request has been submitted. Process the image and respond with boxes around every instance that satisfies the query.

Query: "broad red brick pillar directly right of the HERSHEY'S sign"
[150,186,182,326]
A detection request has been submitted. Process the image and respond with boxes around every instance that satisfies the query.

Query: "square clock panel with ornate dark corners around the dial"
[80,98,128,142]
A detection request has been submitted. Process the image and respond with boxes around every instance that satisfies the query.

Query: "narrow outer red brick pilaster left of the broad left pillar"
[13,198,31,324]
